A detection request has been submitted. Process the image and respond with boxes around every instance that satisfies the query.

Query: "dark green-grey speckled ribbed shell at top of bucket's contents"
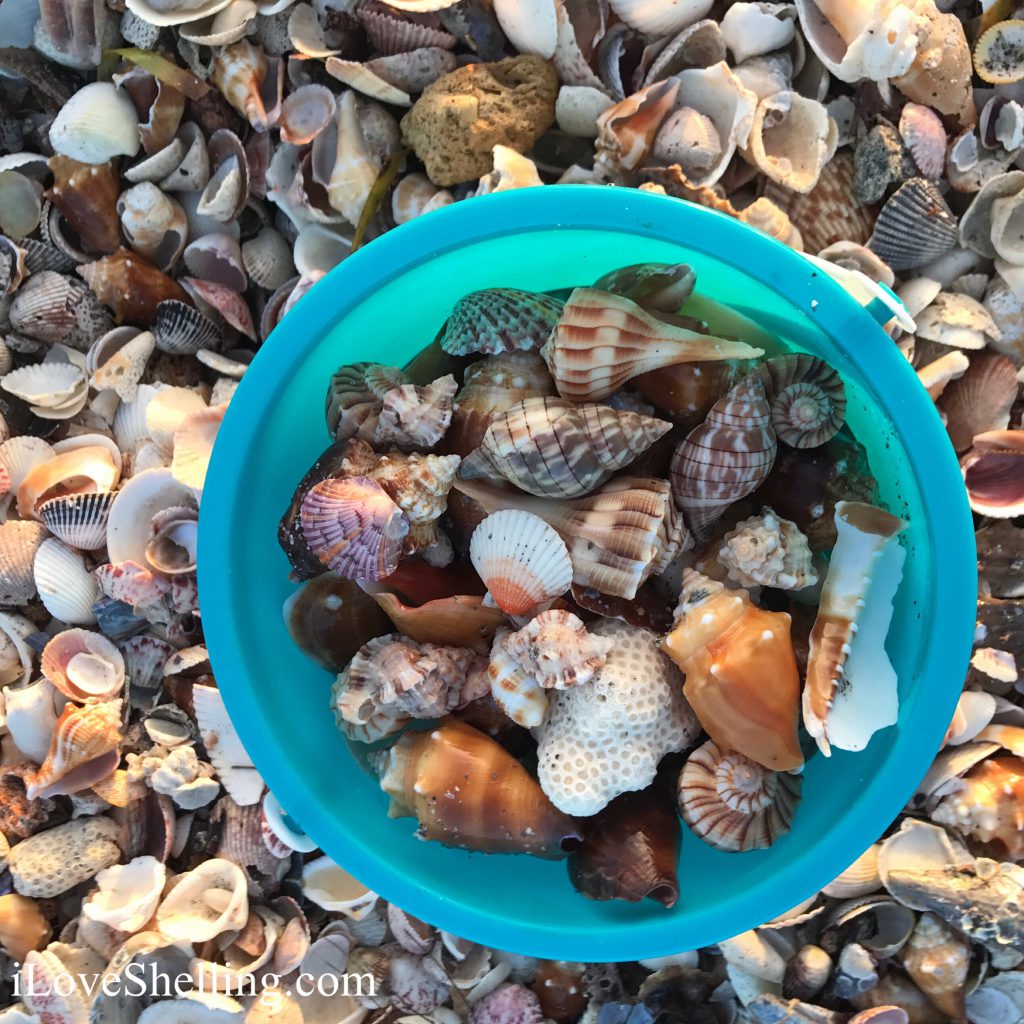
[440,288,562,355]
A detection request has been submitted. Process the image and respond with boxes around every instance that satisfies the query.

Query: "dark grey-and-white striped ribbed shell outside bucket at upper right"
[867,178,957,270]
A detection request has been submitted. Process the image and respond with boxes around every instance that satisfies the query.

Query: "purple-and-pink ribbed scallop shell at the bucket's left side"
[299,476,409,580]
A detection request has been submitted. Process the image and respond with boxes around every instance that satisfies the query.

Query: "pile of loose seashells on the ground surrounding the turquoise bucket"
[0,0,1024,1024]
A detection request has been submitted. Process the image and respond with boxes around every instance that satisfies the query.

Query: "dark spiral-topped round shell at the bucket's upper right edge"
[764,352,846,447]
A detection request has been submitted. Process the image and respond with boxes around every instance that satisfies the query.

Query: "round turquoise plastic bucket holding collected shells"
[199,185,977,961]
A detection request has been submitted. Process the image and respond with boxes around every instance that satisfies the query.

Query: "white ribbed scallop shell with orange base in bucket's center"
[469,509,572,615]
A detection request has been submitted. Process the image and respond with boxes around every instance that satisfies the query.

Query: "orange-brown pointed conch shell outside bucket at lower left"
[26,700,122,800]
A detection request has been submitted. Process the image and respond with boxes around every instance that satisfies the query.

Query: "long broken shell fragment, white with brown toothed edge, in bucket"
[803,502,906,757]
